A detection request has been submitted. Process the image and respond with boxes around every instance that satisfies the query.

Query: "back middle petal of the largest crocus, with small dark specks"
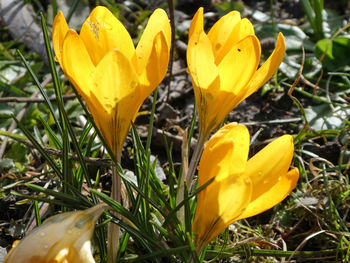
[80,6,135,66]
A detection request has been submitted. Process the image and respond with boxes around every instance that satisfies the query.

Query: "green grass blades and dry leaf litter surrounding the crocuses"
[0,0,350,262]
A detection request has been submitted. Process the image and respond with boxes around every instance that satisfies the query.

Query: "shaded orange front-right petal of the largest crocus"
[140,32,169,94]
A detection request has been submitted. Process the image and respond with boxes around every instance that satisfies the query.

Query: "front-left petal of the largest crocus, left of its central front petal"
[62,29,95,105]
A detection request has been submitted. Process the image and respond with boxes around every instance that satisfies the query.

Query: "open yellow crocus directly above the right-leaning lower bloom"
[187,8,285,138]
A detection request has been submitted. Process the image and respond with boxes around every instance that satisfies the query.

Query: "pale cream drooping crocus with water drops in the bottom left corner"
[4,204,107,263]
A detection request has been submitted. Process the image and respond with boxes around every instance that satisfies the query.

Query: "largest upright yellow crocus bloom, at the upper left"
[52,6,171,156]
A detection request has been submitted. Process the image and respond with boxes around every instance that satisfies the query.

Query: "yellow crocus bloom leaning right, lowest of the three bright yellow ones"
[193,123,299,251]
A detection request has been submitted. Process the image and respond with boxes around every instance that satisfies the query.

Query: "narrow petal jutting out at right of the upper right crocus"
[242,33,286,103]
